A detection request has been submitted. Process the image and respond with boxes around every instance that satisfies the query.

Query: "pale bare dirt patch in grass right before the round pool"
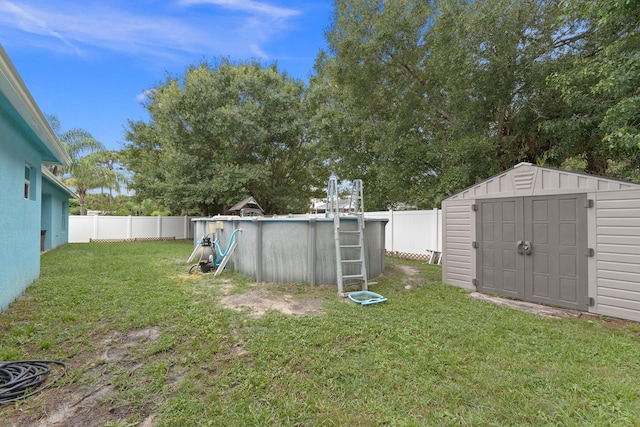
[220,289,324,317]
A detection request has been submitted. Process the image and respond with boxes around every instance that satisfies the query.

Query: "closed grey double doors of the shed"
[476,194,587,310]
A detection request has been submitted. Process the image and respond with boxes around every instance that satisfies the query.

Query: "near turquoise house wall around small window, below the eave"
[0,114,42,311]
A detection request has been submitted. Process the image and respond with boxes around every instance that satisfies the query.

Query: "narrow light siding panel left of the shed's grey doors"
[442,200,475,290]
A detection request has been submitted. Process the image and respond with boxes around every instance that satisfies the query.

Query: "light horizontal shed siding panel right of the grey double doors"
[595,190,640,321]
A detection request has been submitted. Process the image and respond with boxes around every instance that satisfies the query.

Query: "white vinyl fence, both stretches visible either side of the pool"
[69,209,442,255]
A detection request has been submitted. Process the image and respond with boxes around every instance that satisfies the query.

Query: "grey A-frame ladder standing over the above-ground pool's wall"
[327,174,368,297]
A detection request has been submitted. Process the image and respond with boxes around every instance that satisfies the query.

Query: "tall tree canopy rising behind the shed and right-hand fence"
[316,0,640,208]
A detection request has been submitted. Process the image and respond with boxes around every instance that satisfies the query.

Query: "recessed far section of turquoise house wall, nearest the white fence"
[40,179,69,250]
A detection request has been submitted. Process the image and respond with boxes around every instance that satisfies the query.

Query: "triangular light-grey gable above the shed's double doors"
[445,162,640,200]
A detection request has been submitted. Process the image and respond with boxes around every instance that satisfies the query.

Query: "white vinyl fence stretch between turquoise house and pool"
[69,215,193,243]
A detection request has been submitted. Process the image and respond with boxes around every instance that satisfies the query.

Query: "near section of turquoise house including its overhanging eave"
[0,46,71,311]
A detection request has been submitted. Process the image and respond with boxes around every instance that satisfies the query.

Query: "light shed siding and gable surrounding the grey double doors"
[442,163,640,321]
